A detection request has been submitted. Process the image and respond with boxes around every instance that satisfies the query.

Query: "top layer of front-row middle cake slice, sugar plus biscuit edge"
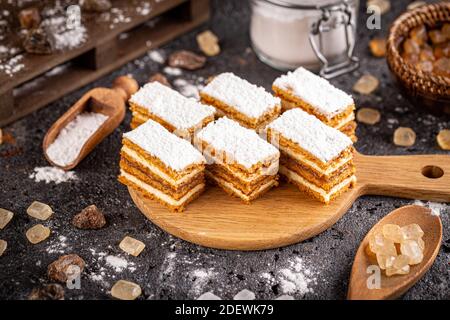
[195,117,280,174]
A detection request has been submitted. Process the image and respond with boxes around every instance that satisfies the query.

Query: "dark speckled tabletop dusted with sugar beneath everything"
[0,0,450,299]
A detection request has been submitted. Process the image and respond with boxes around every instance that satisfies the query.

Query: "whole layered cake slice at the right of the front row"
[267,108,356,204]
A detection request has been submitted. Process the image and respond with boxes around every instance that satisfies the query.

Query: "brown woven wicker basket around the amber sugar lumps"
[387,2,450,114]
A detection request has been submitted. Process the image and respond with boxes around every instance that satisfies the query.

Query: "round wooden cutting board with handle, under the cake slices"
[129,153,450,250]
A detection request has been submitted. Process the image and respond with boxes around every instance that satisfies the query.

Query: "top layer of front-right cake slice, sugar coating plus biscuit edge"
[267,109,353,169]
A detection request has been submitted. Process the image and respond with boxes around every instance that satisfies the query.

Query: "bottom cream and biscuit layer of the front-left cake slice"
[119,171,205,212]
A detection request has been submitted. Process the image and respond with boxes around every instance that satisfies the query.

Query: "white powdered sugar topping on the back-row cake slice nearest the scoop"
[130,81,215,130]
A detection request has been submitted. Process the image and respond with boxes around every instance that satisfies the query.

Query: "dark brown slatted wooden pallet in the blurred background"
[0,0,209,127]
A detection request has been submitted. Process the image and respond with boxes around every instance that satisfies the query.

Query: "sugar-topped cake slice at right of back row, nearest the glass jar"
[272,67,356,141]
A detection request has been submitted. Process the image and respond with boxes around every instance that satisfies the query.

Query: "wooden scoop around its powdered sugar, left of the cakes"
[42,76,139,170]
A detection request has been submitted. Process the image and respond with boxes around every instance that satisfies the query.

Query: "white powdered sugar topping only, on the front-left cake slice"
[124,120,205,171]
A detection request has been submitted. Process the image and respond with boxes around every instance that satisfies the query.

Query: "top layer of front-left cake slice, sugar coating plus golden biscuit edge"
[123,120,206,175]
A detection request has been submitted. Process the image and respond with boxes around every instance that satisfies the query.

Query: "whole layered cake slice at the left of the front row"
[119,120,206,211]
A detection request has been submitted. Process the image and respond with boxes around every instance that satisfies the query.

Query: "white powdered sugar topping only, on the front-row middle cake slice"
[197,117,280,168]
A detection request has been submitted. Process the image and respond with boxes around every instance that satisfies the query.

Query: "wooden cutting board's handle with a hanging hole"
[355,153,450,202]
